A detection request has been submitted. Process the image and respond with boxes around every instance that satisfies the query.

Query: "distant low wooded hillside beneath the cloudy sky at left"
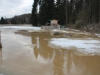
[0,14,31,24]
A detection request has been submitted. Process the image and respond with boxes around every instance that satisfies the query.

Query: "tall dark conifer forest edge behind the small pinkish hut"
[31,0,100,26]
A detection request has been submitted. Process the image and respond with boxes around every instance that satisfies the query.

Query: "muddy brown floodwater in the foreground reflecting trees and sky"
[0,26,100,75]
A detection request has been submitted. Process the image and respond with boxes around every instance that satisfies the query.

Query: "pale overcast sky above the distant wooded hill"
[0,0,33,18]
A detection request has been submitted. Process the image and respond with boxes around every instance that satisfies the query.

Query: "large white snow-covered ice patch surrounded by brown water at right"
[49,38,100,53]
